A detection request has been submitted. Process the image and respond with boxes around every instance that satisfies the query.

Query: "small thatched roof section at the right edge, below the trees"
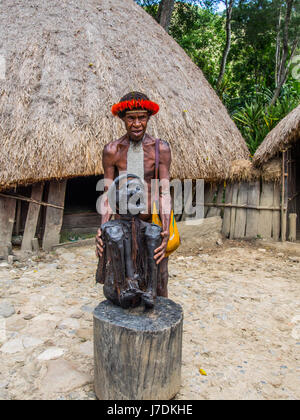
[253,105,300,165]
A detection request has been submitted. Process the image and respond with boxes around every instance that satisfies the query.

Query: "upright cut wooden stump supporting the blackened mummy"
[94,297,183,400]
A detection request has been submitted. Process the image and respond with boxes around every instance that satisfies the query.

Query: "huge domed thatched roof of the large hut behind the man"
[0,0,248,189]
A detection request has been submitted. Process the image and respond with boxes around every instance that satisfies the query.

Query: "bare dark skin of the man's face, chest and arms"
[96,111,171,264]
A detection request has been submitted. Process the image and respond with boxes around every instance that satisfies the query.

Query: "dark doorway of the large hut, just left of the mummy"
[61,175,103,241]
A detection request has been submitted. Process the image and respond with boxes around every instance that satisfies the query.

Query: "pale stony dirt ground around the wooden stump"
[0,240,300,400]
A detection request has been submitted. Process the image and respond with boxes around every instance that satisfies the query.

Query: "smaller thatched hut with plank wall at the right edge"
[220,106,300,241]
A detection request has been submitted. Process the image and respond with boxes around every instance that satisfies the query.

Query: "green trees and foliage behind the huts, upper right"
[136,0,300,153]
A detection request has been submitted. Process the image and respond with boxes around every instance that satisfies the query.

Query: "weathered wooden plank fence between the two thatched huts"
[204,180,282,241]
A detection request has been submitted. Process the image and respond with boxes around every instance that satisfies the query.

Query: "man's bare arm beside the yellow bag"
[154,142,171,264]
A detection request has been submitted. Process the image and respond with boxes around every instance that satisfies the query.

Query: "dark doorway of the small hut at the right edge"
[287,139,300,241]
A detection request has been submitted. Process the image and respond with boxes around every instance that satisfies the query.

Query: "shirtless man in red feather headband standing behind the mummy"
[96,92,171,297]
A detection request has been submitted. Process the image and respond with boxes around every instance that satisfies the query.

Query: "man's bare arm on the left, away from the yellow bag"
[96,143,115,257]
